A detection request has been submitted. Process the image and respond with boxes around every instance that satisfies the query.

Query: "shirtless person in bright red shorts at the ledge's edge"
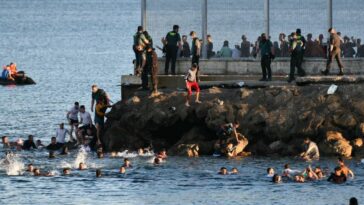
[185,63,201,107]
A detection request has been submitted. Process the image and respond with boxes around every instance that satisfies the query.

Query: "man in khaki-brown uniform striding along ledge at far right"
[321,28,344,75]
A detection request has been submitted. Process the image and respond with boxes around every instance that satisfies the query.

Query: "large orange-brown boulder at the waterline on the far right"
[319,131,353,157]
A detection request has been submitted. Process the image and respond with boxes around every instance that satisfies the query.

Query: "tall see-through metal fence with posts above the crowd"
[141,0,364,57]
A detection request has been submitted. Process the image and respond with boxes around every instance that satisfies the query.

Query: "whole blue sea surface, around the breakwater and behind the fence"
[0,0,364,204]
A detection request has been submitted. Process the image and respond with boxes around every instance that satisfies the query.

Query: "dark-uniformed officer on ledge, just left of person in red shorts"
[164,25,182,75]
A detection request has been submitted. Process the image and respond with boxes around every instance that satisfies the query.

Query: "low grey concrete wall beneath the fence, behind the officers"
[159,58,364,75]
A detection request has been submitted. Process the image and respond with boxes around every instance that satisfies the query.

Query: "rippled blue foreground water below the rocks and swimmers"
[0,150,364,204]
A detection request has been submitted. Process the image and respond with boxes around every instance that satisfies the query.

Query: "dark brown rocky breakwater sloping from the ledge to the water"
[102,84,364,157]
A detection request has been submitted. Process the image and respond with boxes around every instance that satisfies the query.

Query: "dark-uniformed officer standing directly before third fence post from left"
[257,33,275,81]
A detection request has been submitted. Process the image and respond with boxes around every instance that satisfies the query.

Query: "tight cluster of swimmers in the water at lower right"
[267,158,354,184]
